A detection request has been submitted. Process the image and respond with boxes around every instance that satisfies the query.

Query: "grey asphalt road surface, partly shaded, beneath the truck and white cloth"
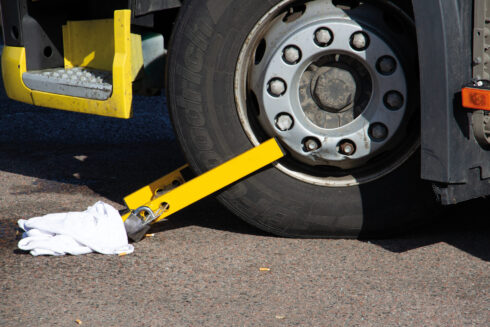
[0,73,490,327]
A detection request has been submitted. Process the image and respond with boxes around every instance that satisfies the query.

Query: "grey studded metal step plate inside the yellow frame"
[22,67,112,100]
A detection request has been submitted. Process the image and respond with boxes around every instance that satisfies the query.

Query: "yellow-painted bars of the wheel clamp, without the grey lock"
[123,139,284,222]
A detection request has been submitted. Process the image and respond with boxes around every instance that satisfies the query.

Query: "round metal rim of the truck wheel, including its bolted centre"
[235,0,418,187]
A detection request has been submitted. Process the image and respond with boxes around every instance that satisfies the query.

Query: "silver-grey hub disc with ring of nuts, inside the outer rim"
[251,0,407,169]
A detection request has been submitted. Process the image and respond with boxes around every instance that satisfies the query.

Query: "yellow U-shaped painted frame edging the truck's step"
[2,10,133,118]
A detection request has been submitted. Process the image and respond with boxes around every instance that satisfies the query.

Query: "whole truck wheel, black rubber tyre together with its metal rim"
[166,0,435,237]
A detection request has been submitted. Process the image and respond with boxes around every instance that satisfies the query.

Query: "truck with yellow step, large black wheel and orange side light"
[0,0,490,237]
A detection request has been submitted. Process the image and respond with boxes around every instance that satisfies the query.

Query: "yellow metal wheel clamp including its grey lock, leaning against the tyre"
[122,139,285,242]
